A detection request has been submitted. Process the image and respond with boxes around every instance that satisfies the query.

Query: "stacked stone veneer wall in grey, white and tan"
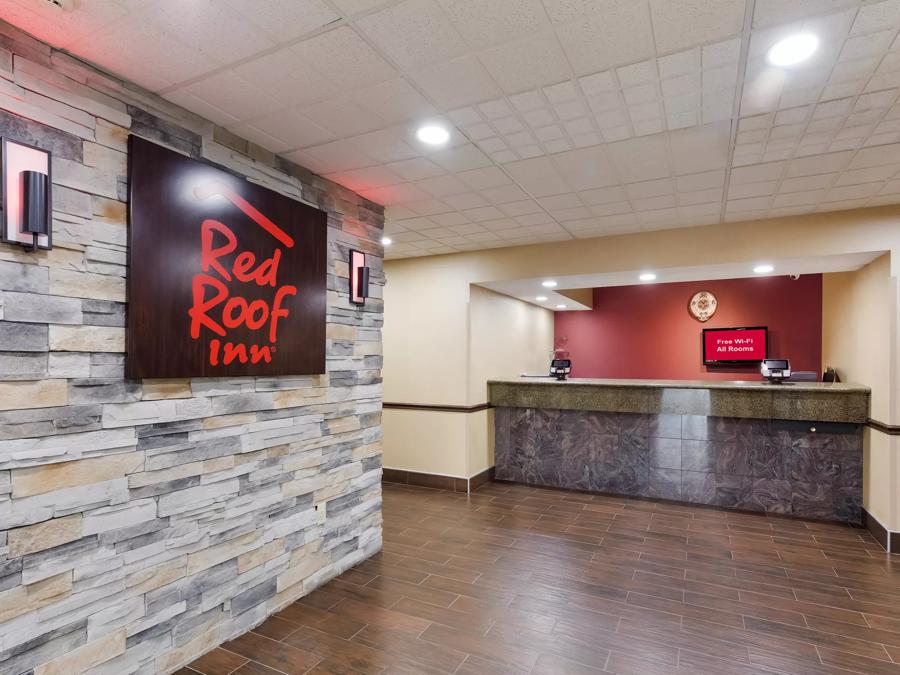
[0,22,383,675]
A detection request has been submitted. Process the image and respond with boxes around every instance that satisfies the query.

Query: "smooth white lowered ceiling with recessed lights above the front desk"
[476,251,884,312]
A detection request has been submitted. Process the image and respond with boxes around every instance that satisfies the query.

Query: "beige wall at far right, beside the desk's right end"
[822,253,900,530]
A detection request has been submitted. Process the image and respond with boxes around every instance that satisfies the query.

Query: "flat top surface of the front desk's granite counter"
[487,377,870,393]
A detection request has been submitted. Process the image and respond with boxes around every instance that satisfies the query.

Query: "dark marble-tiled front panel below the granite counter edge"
[494,407,863,523]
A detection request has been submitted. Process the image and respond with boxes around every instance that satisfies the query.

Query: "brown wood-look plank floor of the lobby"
[179,483,900,675]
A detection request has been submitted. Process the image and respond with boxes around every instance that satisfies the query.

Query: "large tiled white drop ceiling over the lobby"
[0,0,900,257]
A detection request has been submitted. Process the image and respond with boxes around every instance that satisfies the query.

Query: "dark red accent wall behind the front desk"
[555,274,822,380]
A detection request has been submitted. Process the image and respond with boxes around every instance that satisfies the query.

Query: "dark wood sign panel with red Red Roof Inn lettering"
[125,136,327,378]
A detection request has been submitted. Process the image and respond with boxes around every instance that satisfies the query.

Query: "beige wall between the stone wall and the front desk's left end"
[383,282,553,478]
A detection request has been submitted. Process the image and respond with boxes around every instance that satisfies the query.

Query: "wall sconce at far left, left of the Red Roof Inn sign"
[0,138,53,251]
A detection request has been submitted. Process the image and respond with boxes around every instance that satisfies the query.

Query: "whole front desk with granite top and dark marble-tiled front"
[488,378,869,524]
